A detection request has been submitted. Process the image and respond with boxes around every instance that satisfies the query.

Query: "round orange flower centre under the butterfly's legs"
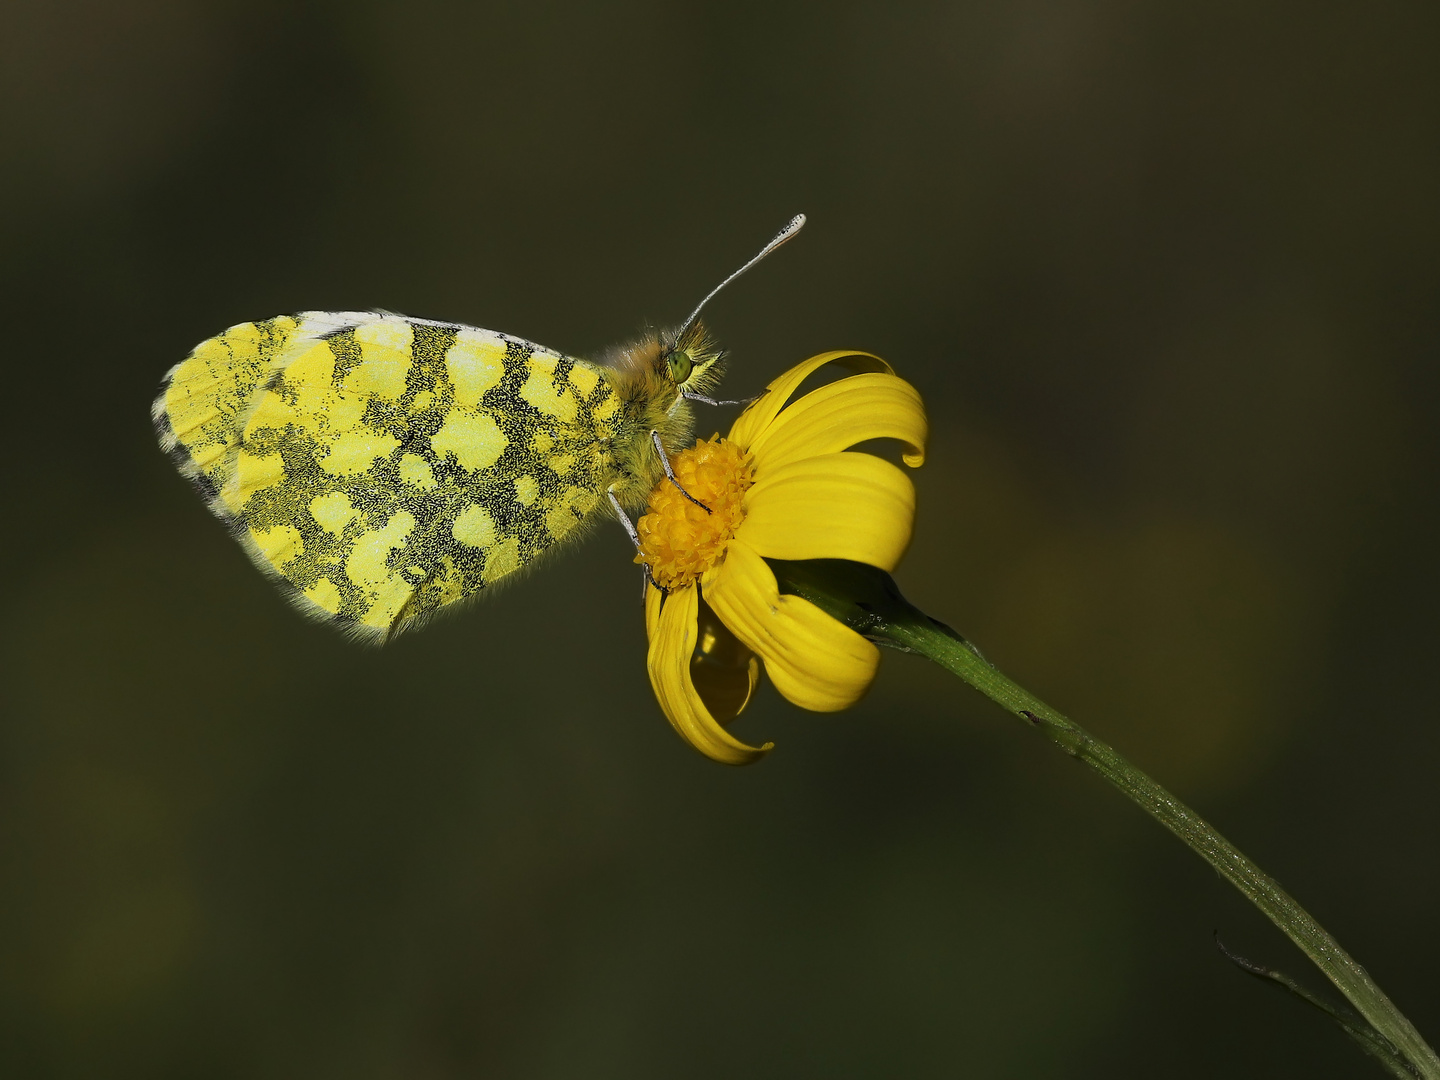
[635,435,755,589]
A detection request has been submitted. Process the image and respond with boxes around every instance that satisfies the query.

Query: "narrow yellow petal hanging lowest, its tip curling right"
[645,586,773,765]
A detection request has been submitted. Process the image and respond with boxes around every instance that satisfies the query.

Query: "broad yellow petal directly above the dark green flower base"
[737,451,914,570]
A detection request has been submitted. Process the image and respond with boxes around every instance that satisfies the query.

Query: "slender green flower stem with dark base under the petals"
[770,559,1440,1080]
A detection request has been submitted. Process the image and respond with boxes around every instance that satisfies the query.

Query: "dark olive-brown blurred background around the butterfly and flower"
[0,0,1440,1079]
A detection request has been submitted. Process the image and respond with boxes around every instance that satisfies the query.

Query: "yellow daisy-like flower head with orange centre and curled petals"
[636,351,926,765]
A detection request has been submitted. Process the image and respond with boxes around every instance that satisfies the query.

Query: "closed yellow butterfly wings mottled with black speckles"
[156,312,621,639]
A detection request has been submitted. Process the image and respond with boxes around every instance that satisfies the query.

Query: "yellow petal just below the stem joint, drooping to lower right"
[700,544,893,713]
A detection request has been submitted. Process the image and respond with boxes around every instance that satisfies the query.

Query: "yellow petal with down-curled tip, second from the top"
[750,372,926,472]
